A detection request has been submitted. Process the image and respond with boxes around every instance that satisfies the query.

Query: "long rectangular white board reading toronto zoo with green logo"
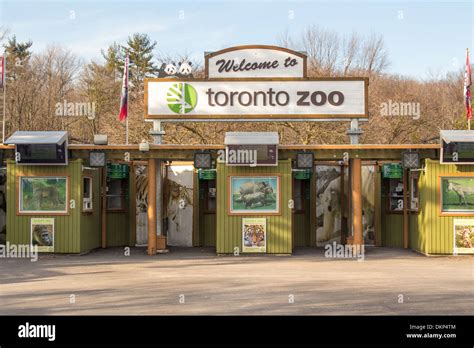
[145,78,368,121]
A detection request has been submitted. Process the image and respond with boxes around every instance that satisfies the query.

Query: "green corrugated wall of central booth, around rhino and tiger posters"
[216,160,292,254]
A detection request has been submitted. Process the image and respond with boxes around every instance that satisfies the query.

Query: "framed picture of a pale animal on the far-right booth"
[440,176,474,214]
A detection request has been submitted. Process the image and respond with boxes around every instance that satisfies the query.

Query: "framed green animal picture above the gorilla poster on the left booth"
[19,176,67,213]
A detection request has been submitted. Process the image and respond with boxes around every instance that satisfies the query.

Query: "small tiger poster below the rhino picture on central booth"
[242,218,267,253]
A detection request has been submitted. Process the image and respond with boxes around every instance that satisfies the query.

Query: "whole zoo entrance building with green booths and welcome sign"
[0,46,474,255]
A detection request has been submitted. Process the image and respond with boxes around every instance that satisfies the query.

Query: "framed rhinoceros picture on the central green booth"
[228,175,280,214]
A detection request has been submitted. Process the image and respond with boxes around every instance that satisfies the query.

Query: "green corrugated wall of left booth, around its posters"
[7,160,82,253]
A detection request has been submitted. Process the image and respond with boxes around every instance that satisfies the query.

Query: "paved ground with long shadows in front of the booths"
[0,248,474,315]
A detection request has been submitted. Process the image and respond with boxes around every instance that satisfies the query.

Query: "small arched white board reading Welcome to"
[204,45,307,78]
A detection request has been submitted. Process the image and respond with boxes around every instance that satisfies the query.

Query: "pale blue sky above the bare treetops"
[0,0,474,78]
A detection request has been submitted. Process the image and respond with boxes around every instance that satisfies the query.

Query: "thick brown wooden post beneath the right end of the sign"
[350,158,364,245]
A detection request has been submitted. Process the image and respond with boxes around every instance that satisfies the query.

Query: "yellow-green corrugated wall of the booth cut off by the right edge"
[417,160,474,254]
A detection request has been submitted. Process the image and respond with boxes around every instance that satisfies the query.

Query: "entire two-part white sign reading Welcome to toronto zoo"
[145,46,368,122]
